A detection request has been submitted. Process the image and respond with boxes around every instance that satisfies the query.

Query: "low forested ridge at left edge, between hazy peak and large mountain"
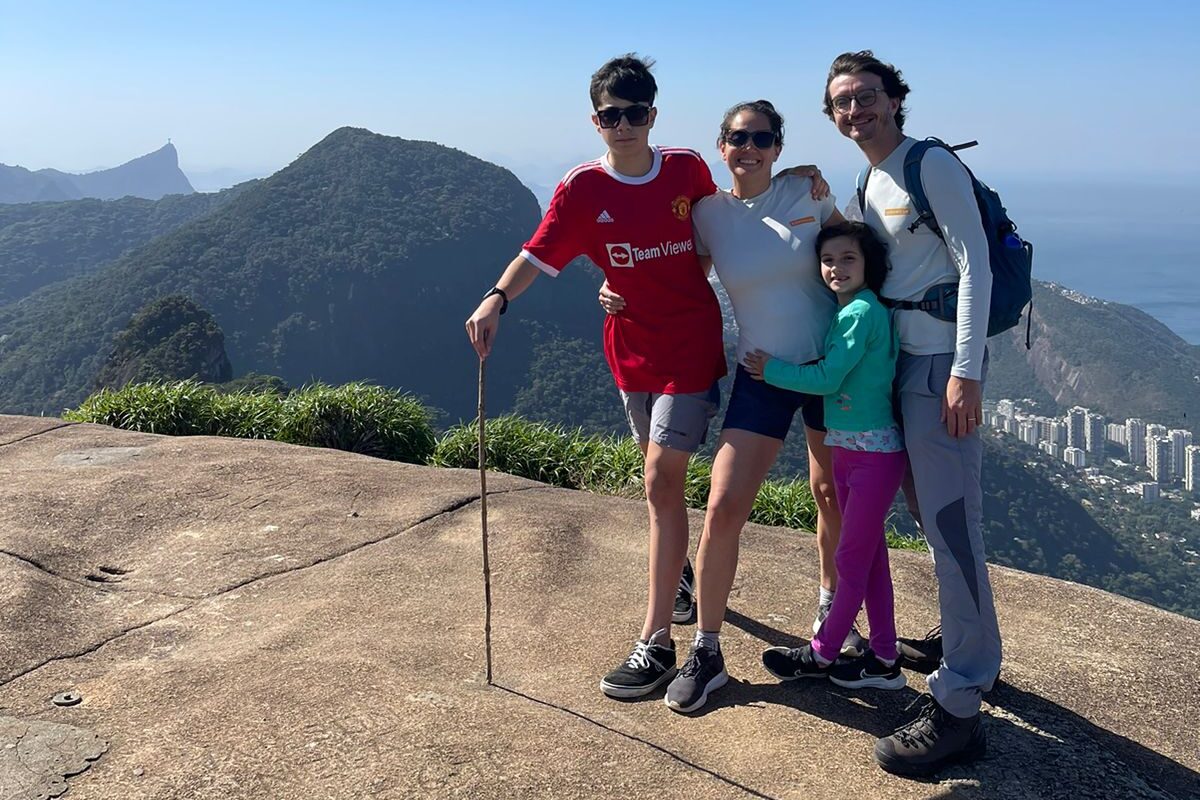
[0,188,254,306]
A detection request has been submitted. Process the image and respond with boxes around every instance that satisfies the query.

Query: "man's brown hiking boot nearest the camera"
[875,694,988,777]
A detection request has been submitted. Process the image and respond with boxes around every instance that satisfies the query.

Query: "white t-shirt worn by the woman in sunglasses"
[691,175,838,363]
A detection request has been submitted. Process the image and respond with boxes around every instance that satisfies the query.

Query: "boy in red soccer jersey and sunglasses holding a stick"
[467,54,725,697]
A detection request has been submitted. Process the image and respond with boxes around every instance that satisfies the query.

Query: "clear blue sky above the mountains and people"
[0,0,1200,191]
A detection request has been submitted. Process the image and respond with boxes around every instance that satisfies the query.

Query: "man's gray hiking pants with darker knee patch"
[896,351,1000,717]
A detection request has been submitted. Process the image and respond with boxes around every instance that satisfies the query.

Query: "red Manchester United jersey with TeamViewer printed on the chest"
[521,148,725,395]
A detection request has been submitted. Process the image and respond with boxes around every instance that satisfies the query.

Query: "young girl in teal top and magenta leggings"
[745,222,906,688]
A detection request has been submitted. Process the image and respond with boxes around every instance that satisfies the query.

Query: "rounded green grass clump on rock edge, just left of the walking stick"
[276,383,436,464]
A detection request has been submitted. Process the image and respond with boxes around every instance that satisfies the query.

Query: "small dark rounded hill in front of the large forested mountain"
[96,294,233,389]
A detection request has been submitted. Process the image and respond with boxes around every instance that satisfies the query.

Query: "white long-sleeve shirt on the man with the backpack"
[863,137,991,380]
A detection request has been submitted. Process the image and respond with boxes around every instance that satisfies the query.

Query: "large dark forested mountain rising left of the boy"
[0,128,602,417]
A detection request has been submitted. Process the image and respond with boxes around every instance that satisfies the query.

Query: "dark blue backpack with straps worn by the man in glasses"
[858,138,1033,349]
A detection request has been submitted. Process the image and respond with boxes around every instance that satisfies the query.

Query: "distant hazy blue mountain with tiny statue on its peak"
[0,143,196,203]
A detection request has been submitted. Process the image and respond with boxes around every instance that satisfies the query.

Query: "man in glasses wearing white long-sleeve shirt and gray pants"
[824,50,1001,775]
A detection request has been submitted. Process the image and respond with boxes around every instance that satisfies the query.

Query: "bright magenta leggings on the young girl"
[812,447,907,661]
